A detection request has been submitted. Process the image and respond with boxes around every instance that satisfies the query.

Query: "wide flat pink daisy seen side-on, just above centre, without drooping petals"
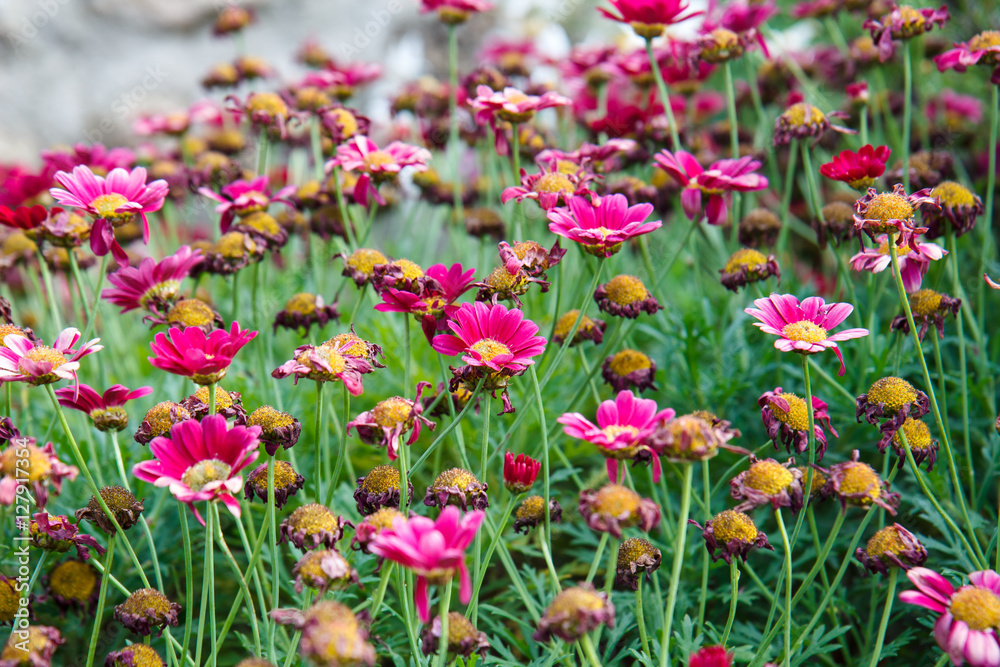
[548,195,663,257]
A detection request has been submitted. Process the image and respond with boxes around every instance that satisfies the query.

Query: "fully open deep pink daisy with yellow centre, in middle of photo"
[431,302,547,412]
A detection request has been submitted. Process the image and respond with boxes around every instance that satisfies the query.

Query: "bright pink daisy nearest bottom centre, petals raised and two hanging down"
[369,505,486,623]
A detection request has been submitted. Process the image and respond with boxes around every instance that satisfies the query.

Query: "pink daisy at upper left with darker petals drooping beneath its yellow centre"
[49,165,170,266]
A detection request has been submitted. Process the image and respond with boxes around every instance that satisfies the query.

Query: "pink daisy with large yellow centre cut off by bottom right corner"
[899,567,1000,667]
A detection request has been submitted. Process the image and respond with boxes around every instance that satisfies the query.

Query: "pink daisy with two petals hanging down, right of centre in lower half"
[556,391,676,484]
